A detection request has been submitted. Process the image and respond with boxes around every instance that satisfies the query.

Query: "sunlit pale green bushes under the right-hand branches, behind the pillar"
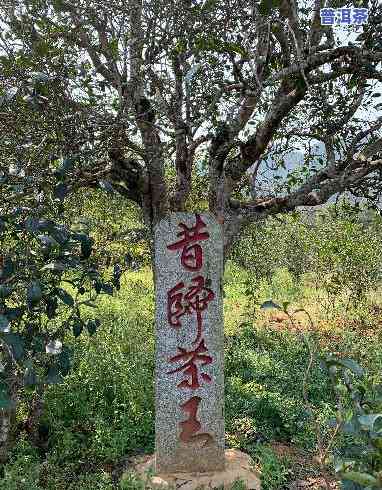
[231,202,382,309]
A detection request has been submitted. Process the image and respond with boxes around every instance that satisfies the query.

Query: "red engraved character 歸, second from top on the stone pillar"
[167,276,215,344]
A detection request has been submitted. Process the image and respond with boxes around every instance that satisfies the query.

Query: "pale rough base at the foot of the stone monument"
[124,449,261,490]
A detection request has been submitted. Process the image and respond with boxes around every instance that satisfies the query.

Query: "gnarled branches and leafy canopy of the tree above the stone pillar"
[0,0,382,251]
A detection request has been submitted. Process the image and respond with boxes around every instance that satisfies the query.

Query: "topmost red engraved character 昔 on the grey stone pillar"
[167,214,210,271]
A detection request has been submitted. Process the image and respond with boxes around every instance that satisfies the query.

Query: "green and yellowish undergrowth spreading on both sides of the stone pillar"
[0,193,382,490]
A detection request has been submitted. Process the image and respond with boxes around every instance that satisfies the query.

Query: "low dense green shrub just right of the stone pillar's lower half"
[225,324,333,449]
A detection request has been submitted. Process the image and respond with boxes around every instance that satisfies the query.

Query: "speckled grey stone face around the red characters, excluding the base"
[155,213,225,473]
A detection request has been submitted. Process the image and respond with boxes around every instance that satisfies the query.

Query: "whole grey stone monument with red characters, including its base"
[123,213,261,490]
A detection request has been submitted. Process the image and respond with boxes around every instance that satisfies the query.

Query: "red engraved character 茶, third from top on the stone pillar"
[167,339,212,390]
